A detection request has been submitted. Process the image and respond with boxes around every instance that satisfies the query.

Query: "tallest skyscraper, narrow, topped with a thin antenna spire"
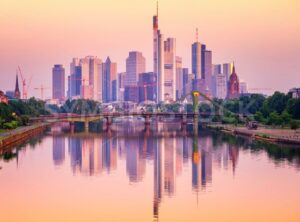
[153,5,165,102]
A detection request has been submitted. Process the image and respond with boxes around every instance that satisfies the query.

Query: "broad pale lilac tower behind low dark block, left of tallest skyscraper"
[125,52,146,86]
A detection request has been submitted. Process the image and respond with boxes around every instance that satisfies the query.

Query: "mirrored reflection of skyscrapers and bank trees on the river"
[0,126,300,219]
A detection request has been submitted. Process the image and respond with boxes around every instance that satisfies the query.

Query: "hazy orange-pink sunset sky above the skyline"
[0,0,300,96]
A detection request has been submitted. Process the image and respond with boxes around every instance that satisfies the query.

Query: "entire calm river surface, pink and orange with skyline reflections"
[0,125,300,222]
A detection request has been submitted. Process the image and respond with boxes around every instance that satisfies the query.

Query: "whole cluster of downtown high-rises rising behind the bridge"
[54,2,248,103]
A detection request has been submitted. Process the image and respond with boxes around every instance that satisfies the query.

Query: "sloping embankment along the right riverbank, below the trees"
[207,124,300,146]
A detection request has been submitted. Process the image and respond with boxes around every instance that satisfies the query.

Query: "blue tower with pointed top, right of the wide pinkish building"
[102,57,117,103]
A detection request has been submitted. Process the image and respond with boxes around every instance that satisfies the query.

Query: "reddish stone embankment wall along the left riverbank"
[0,123,50,149]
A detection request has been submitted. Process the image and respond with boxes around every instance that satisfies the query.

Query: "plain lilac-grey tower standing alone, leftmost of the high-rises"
[52,65,65,101]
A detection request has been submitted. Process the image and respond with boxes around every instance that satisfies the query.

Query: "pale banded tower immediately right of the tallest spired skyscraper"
[164,38,176,100]
